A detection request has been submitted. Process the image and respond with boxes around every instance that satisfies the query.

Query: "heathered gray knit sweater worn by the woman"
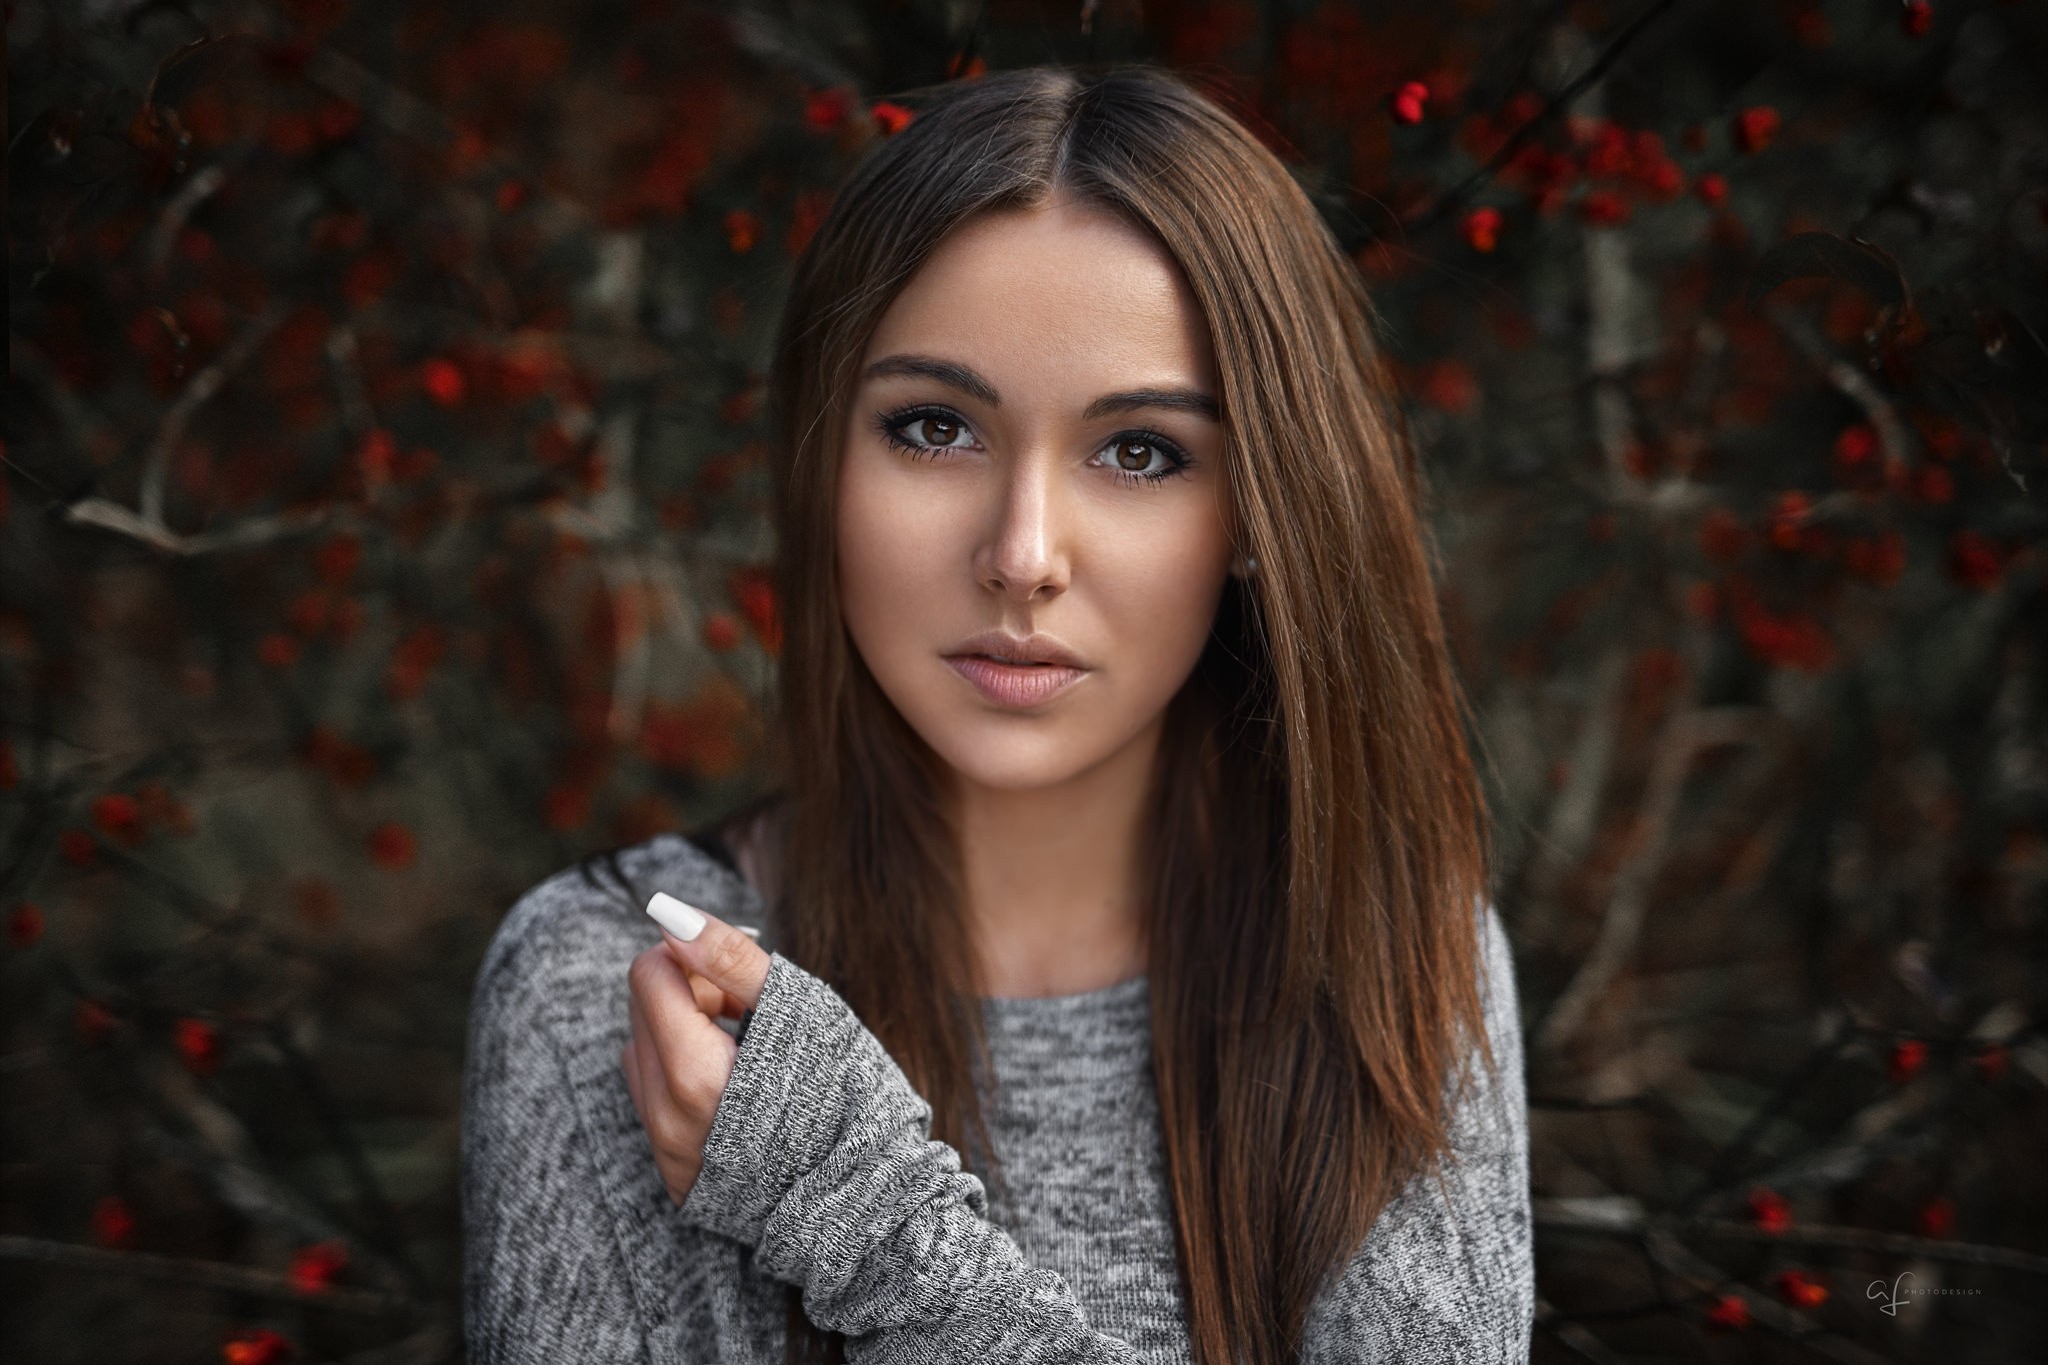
[461,835,1536,1365]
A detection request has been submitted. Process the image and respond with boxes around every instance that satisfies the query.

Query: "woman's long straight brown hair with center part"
[768,68,1493,1365]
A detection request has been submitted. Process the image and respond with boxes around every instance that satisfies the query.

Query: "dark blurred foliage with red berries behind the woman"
[0,0,2048,1365]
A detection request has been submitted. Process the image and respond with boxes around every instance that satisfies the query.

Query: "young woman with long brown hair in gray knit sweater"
[463,70,1534,1365]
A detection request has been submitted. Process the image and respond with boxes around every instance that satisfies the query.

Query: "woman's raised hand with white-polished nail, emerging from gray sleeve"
[618,896,770,1207]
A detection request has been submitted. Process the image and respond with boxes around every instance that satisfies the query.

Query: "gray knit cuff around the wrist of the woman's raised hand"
[680,954,950,1248]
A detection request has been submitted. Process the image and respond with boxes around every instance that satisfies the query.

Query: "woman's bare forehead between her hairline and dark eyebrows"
[866,201,1214,397]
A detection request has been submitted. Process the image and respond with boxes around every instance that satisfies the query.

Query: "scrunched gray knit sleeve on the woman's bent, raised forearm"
[682,954,1139,1365]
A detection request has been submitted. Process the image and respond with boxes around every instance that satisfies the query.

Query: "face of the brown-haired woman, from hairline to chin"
[838,201,1231,792]
